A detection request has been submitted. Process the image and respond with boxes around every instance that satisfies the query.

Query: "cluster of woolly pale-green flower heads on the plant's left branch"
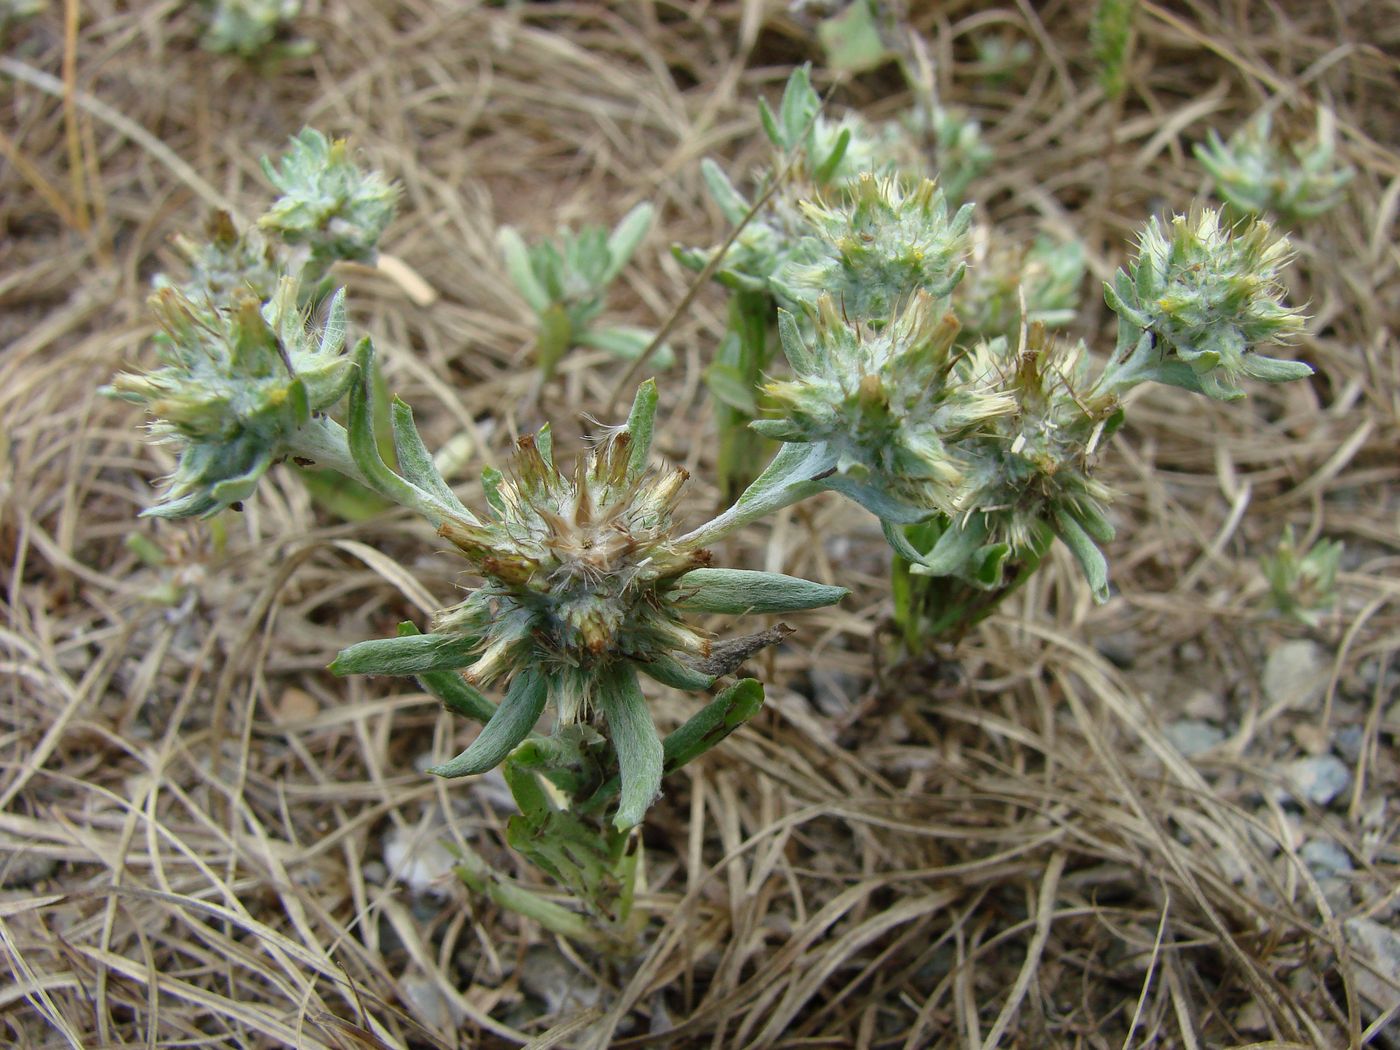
[106,129,398,518]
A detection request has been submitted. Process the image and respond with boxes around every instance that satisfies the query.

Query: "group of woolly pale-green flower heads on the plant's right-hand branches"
[752,166,1312,601]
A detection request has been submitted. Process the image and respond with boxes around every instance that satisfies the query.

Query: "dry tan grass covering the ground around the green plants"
[0,0,1400,1049]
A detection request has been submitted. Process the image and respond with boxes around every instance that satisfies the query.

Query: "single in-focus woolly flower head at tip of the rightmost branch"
[1105,210,1312,400]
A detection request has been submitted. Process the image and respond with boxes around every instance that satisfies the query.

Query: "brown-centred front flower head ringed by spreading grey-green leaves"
[332,381,846,827]
